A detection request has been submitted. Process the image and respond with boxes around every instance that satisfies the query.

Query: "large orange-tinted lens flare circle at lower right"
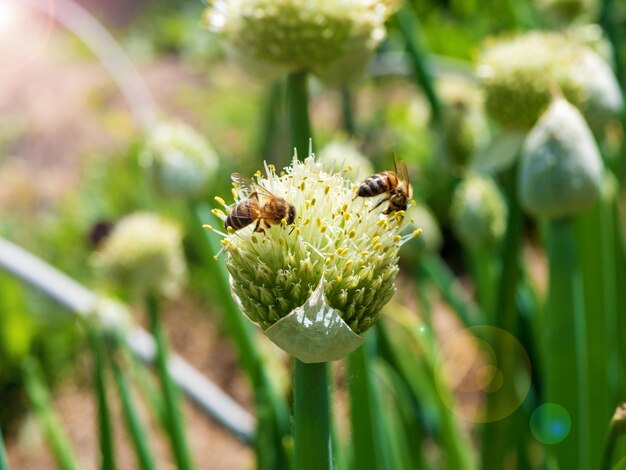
[435,326,531,423]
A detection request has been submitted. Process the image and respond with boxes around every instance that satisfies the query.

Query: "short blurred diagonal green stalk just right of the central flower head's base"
[419,255,486,328]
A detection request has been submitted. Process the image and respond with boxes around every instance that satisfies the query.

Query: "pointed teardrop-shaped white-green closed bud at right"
[519,98,603,218]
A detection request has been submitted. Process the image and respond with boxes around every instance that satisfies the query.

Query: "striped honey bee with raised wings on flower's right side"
[357,153,411,214]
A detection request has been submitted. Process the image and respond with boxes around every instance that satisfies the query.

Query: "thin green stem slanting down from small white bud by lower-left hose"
[110,337,156,470]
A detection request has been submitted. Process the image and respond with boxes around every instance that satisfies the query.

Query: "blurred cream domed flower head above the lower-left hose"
[92,212,186,297]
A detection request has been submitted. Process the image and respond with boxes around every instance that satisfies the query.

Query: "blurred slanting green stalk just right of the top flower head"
[396,2,443,128]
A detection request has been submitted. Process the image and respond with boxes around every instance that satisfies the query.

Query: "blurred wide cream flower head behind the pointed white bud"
[477,32,623,130]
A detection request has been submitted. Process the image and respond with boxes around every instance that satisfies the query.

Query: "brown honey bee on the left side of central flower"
[224,173,296,233]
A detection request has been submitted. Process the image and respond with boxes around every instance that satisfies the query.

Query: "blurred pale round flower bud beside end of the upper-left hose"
[140,123,219,195]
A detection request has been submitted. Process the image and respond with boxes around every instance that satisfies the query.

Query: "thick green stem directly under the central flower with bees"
[293,359,333,470]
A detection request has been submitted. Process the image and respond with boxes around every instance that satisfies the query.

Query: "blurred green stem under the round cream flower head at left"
[146,295,192,470]
